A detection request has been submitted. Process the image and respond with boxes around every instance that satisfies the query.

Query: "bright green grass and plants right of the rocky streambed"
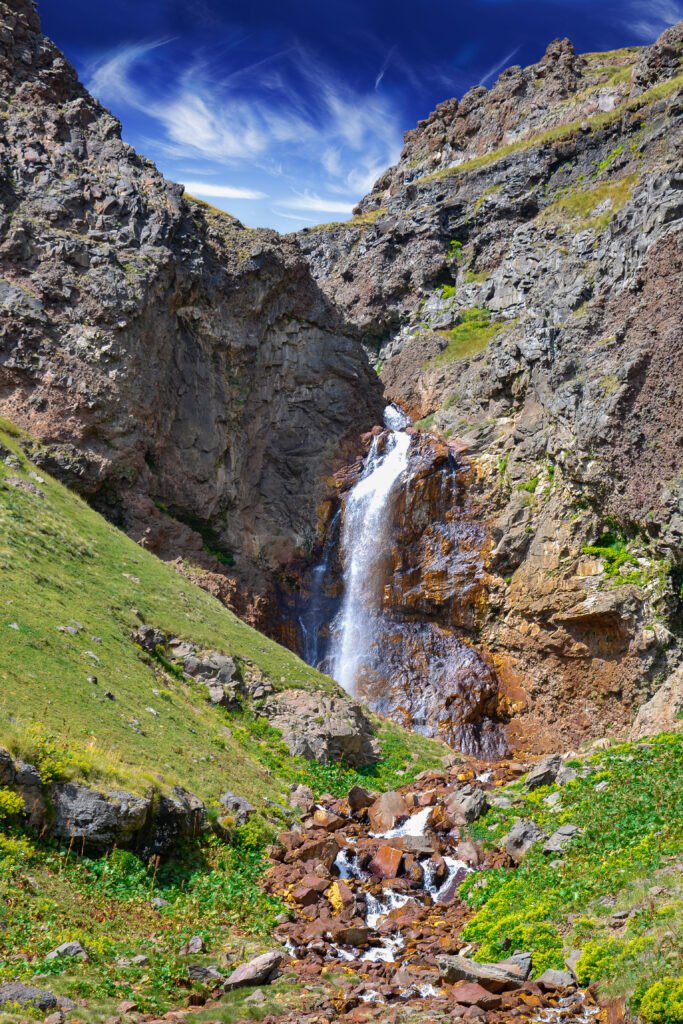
[461,734,683,1011]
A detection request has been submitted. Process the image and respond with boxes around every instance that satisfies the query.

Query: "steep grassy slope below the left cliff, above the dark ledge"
[0,423,443,803]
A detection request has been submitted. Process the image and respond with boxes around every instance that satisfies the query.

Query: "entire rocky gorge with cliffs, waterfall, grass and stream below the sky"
[0,6,683,1024]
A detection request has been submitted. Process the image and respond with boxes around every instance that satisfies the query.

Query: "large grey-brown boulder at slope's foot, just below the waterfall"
[260,689,379,768]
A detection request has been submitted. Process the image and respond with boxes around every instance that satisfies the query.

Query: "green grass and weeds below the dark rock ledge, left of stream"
[0,826,284,1021]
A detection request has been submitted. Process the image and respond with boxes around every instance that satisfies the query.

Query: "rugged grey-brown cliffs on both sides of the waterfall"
[0,0,683,750]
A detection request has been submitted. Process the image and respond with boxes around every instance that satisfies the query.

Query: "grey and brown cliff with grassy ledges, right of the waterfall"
[298,24,683,753]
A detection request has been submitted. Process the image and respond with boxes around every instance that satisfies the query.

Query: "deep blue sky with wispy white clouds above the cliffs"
[39,0,683,231]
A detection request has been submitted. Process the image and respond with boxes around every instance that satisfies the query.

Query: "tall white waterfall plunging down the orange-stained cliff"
[331,406,411,693]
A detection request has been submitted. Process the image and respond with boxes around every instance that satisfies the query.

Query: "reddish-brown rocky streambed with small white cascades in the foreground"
[258,758,600,1022]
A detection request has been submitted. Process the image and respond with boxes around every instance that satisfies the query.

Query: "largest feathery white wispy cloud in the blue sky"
[87,39,402,220]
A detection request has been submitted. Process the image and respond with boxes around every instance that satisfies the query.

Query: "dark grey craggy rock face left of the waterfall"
[0,0,382,610]
